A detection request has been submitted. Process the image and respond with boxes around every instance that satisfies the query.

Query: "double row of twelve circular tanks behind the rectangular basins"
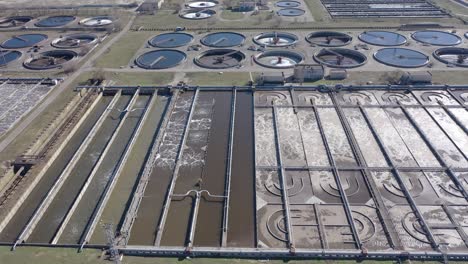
[132,31,468,69]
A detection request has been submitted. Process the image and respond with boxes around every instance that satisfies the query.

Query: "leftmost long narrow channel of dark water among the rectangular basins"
[0,96,112,242]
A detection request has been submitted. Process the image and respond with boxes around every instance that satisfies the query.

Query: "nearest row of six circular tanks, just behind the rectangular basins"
[135,47,468,69]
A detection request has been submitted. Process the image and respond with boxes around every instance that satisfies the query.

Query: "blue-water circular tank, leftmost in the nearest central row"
[135,49,187,70]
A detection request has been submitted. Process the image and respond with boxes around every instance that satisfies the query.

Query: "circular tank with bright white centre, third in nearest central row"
[254,50,304,69]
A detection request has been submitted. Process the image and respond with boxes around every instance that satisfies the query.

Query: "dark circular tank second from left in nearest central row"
[195,49,245,69]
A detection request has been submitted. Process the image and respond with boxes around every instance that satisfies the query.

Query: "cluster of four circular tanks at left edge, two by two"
[0,33,98,70]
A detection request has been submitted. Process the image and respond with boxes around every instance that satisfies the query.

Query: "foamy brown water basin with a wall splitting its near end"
[162,92,232,246]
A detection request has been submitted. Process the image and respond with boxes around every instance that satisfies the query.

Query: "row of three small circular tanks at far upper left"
[0,15,114,28]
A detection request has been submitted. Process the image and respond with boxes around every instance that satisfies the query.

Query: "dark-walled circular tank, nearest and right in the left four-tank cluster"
[23,50,78,70]
